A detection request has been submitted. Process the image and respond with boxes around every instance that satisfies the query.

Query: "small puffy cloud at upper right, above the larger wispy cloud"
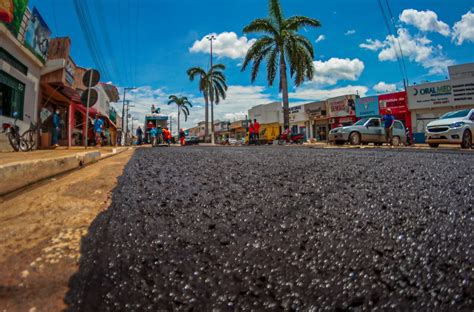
[400,9,451,37]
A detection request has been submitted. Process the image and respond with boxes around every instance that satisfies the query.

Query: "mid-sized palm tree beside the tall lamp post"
[187,64,228,138]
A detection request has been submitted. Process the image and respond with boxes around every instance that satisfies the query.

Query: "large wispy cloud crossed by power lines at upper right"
[360,28,454,75]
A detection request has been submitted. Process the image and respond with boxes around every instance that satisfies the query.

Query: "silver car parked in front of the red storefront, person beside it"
[329,117,407,146]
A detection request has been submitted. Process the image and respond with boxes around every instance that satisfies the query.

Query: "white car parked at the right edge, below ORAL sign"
[425,108,474,148]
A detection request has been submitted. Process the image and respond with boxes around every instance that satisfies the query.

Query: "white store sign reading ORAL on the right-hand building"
[407,78,474,109]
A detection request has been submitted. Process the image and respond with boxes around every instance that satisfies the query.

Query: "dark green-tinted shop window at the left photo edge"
[0,71,25,120]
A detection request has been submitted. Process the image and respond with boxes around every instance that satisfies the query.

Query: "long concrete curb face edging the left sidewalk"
[0,147,128,196]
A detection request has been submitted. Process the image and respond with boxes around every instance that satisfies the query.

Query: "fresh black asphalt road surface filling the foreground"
[65,147,474,311]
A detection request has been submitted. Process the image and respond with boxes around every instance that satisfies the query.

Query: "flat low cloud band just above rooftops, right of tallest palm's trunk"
[289,85,369,101]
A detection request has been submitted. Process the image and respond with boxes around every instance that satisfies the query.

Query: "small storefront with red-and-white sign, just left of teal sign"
[327,94,358,128]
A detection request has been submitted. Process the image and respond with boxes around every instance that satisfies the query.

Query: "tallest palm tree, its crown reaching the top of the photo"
[242,0,321,128]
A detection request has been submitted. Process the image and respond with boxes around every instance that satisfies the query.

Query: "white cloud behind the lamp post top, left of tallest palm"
[189,32,256,59]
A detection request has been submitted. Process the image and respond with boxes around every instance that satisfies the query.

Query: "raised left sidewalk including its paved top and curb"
[0,146,129,196]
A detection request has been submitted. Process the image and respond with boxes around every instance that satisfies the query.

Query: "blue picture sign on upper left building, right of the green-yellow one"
[25,8,51,60]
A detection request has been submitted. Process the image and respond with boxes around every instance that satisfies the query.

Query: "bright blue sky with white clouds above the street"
[30,0,474,126]
